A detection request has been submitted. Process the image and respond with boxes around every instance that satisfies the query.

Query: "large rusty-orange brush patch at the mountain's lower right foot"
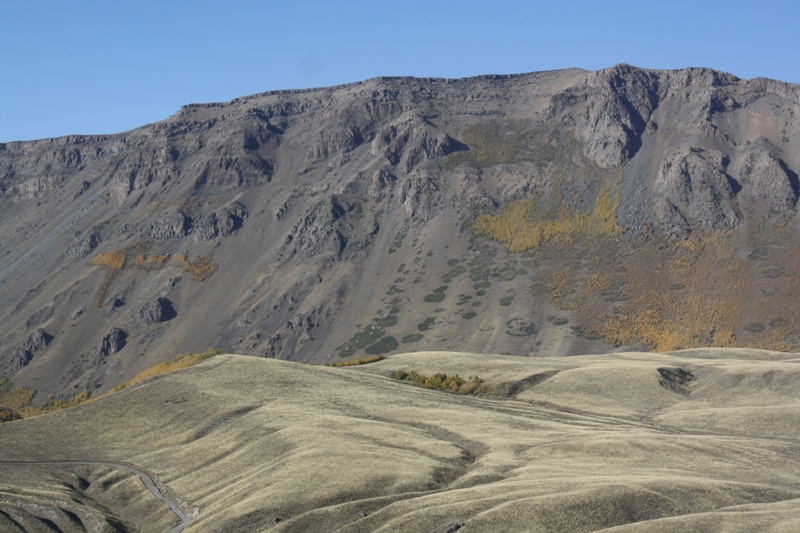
[543,223,800,352]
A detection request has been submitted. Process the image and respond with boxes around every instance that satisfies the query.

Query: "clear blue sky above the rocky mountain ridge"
[0,0,800,142]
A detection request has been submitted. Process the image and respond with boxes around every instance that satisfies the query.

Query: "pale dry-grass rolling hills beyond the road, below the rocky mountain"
[0,349,800,532]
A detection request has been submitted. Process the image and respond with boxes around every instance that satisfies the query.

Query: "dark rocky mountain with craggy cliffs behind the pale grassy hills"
[0,65,800,404]
